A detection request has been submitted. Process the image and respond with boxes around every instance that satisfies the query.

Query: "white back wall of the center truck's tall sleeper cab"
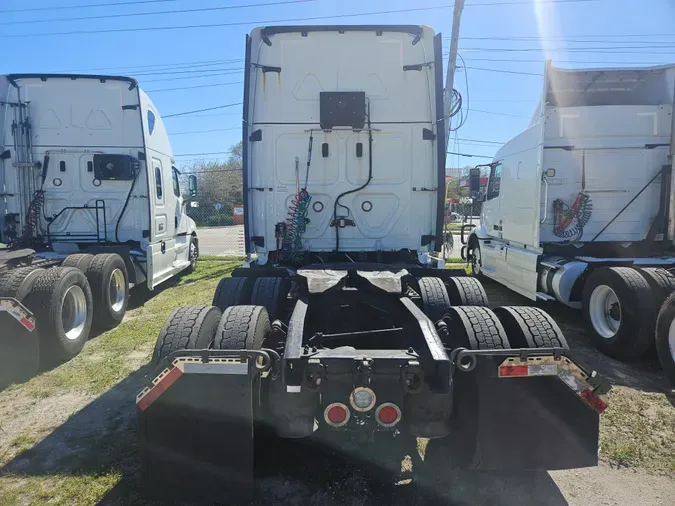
[243,25,445,256]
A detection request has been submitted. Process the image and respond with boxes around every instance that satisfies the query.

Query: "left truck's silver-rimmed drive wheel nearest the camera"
[26,267,94,361]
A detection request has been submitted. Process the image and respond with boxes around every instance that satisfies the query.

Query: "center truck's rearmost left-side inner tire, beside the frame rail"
[213,306,272,350]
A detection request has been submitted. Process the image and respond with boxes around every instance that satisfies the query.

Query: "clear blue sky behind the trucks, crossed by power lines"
[0,0,675,170]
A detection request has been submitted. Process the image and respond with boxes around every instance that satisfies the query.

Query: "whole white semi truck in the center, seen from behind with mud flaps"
[137,25,606,503]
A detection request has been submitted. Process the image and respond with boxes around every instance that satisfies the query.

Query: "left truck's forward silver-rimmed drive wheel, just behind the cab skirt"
[83,253,129,330]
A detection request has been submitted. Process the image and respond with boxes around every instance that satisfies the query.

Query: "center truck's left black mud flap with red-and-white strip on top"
[137,358,259,504]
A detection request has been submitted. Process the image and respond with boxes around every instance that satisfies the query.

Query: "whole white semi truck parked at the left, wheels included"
[0,74,198,384]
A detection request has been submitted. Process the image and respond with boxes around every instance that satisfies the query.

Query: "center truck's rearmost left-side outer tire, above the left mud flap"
[152,306,221,364]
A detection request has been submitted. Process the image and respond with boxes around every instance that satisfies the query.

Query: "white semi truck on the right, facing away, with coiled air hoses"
[463,62,675,380]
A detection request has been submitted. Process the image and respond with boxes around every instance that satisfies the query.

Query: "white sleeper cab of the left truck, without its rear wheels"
[0,74,198,289]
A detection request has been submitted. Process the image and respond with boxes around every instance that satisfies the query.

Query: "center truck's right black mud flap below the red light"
[449,356,604,471]
